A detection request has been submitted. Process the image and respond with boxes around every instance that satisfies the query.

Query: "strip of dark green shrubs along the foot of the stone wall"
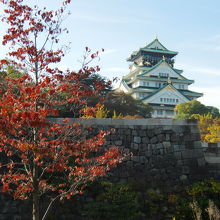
[81,179,220,220]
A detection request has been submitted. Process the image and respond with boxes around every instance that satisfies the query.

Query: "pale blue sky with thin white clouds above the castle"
[0,0,220,109]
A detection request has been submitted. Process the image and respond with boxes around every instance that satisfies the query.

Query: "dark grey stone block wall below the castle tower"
[0,119,220,220]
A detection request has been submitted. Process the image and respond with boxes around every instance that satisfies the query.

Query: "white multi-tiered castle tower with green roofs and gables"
[116,38,203,118]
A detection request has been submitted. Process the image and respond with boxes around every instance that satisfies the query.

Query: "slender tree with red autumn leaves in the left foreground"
[0,0,122,220]
